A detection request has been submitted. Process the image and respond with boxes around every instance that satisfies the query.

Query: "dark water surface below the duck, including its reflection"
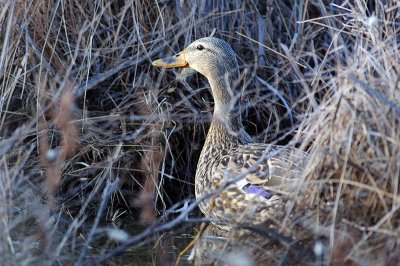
[86,215,315,266]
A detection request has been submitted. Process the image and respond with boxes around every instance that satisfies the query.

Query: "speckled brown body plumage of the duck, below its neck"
[195,122,308,225]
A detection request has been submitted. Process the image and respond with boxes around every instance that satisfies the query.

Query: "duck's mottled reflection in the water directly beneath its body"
[189,225,310,266]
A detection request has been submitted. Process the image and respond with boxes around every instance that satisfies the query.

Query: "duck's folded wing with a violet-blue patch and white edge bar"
[213,143,309,198]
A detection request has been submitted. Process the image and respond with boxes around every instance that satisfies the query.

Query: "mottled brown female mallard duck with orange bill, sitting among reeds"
[153,37,308,227]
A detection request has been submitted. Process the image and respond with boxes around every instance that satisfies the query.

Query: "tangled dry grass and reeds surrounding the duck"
[0,0,400,265]
